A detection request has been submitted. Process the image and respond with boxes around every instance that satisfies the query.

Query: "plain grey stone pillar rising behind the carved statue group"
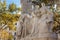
[21,0,32,14]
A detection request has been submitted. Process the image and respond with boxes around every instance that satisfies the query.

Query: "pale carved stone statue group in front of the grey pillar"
[17,3,57,40]
